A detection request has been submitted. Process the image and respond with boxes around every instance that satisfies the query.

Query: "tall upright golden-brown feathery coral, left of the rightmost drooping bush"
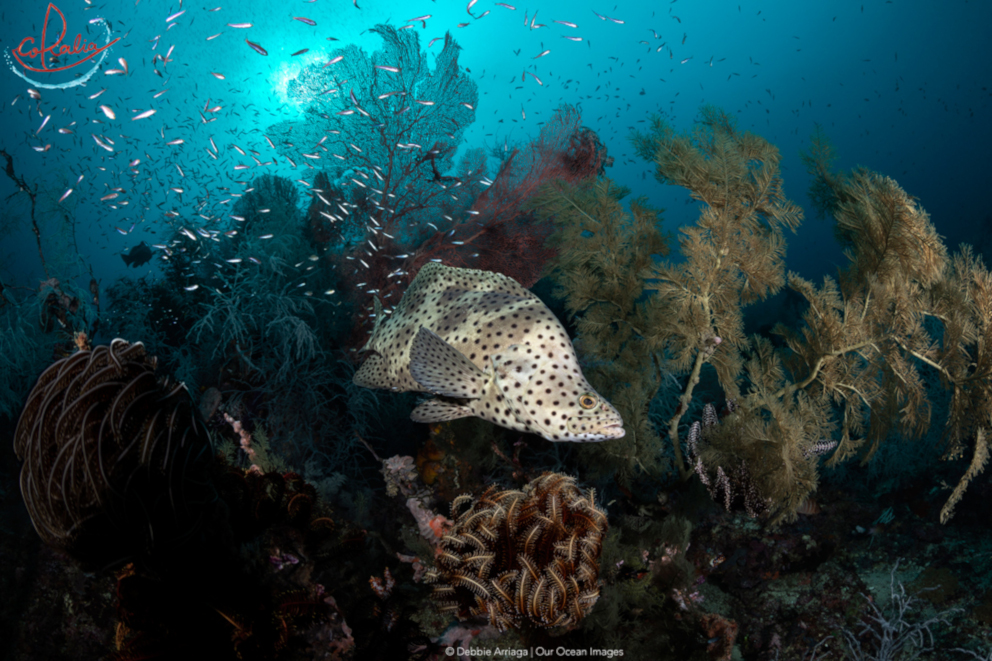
[632,107,802,475]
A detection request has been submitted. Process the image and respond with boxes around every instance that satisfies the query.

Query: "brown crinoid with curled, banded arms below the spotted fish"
[427,473,607,631]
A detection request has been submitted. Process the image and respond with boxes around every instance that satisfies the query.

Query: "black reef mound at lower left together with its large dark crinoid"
[6,340,372,661]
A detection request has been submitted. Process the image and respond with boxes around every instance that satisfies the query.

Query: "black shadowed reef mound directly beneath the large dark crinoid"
[112,466,355,660]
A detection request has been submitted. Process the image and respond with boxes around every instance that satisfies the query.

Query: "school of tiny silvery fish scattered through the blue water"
[11,0,719,276]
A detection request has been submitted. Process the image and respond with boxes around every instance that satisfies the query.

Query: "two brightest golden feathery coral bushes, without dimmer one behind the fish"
[634,109,992,521]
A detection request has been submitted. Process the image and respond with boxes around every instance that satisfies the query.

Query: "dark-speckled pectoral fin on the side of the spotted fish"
[410,326,489,398]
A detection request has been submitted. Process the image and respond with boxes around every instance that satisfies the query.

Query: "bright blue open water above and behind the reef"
[0,1,992,283]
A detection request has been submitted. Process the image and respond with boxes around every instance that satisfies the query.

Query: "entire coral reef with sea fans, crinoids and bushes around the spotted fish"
[7,80,992,661]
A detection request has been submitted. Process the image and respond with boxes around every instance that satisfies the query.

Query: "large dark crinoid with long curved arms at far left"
[14,339,212,565]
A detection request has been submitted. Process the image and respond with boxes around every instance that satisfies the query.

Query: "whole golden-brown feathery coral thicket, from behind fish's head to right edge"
[538,107,992,522]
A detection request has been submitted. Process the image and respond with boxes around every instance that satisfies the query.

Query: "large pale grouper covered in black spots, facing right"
[354,262,624,442]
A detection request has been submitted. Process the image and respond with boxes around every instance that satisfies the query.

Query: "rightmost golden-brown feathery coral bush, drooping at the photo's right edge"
[777,148,992,523]
